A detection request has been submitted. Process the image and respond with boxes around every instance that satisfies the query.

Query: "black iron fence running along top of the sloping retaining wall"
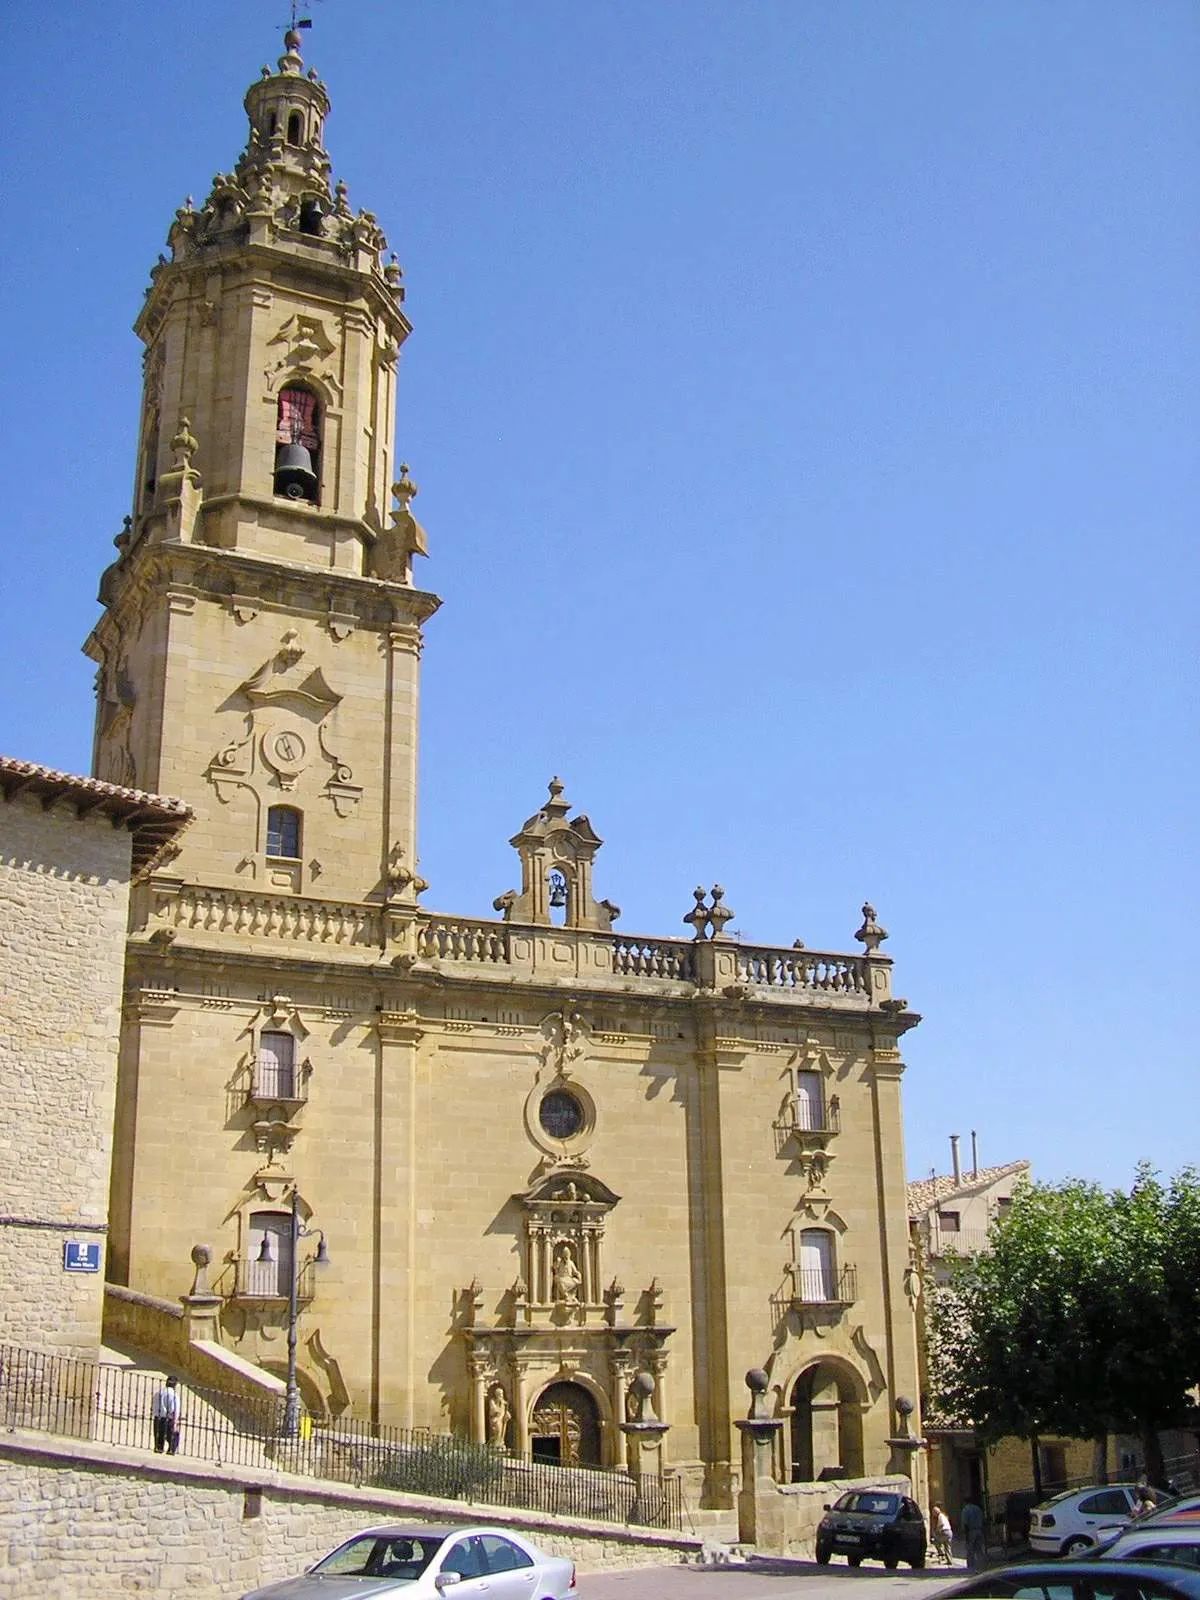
[0,1344,683,1530]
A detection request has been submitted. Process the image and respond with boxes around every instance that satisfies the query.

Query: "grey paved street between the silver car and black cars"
[579,1557,966,1600]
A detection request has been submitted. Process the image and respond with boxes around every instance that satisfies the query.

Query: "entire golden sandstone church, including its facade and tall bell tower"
[86,34,917,1506]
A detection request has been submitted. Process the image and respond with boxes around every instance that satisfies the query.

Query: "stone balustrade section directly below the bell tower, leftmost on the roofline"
[154,883,382,947]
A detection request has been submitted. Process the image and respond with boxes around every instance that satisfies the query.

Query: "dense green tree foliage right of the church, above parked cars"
[928,1166,1200,1465]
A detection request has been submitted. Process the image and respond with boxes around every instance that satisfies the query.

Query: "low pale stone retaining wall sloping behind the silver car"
[0,1435,699,1600]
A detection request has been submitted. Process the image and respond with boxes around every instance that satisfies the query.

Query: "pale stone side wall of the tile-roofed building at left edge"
[0,795,131,1354]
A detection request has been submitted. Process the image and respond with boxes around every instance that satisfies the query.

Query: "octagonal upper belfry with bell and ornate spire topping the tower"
[119,29,411,571]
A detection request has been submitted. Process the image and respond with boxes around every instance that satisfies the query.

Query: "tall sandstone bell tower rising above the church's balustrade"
[85,32,438,902]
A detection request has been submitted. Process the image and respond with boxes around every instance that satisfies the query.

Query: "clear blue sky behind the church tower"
[0,0,1200,1182]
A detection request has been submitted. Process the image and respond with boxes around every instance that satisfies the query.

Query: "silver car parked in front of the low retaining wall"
[243,1523,576,1600]
